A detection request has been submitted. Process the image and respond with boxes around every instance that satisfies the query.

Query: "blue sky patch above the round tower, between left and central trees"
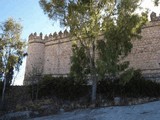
[0,0,64,39]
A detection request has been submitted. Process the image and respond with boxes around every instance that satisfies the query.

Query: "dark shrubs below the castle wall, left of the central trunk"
[39,75,89,100]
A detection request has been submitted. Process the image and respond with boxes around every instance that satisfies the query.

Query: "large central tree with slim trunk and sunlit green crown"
[40,0,146,102]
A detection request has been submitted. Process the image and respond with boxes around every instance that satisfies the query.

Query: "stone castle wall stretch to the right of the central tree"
[127,21,160,79]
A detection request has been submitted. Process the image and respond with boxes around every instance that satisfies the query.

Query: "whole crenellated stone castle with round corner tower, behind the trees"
[24,12,160,85]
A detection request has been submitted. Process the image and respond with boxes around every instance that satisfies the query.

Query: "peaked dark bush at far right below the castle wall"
[124,71,160,97]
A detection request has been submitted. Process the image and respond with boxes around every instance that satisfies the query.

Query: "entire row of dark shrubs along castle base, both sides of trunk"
[34,70,160,101]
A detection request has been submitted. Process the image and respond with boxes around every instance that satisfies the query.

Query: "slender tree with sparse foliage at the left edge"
[0,18,25,105]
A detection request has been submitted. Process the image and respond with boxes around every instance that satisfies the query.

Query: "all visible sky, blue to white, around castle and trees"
[0,0,160,85]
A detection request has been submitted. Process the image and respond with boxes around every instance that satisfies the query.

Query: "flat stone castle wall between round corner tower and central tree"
[43,31,72,75]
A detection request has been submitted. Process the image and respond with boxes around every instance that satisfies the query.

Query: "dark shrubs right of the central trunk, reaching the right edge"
[98,70,160,99]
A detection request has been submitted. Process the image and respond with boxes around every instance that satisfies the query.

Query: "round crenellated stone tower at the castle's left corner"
[23,33,45,85]
